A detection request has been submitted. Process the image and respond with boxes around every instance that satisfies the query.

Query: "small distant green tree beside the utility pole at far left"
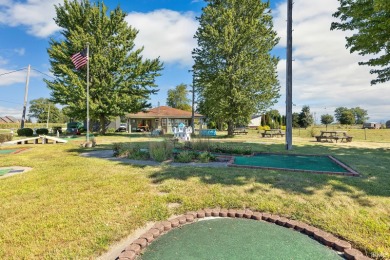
[28,98,64,123]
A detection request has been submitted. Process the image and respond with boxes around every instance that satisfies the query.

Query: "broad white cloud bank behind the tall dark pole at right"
[274,0,390,121]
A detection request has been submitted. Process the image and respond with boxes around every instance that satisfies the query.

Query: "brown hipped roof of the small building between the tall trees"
[126,106,203,118]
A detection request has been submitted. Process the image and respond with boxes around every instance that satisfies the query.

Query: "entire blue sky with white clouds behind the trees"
[0,0,390,123]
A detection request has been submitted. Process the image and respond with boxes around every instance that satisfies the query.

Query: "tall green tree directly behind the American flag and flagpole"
[46,0,162,133]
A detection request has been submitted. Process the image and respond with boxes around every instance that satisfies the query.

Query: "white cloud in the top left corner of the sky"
[0,0,59,37]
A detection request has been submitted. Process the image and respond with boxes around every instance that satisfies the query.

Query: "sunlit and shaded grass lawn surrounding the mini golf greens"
[0,133,390,259]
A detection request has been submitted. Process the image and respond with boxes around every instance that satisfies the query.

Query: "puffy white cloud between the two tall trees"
[126,9,198,66]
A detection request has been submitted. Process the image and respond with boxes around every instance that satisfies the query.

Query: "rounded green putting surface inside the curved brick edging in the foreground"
[141,218,343,260]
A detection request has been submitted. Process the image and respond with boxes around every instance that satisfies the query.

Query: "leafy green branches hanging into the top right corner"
[331,0,390,85]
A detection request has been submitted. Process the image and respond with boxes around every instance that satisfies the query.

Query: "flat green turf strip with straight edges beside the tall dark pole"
[234,154,348,172]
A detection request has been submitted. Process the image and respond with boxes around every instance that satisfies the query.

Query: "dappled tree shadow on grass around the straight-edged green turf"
[143,141,390,200]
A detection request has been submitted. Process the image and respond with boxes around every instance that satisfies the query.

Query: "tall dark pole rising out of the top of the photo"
[286,0,293,150]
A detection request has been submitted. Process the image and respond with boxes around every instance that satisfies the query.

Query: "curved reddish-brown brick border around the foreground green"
[117,208,371,260]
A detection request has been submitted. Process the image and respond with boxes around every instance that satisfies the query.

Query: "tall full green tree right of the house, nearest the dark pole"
[193,0,280,135]
